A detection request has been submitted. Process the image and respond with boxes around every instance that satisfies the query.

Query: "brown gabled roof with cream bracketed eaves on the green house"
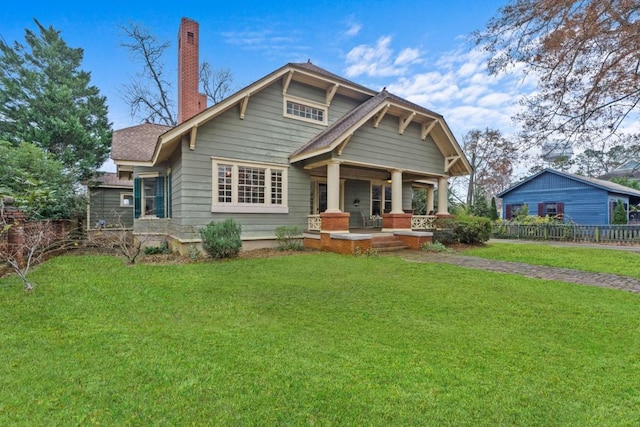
[111,62,471,175]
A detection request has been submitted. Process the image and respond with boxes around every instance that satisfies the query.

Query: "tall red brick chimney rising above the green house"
[178,18,207,124]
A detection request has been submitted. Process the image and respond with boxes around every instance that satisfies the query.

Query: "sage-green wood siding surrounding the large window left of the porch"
[174,82,332,238]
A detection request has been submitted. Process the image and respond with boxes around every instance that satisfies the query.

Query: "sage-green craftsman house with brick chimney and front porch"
[112,18,471,254]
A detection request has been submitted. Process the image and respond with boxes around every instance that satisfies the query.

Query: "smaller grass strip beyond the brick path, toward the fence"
[464,242,640,279]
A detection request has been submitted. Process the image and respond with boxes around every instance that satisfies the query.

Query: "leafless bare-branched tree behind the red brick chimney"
[120,23,233,126]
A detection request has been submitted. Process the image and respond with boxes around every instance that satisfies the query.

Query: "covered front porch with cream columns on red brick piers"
[305,159,450,253]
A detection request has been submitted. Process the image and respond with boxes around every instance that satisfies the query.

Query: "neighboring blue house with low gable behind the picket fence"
[497,169,640,225]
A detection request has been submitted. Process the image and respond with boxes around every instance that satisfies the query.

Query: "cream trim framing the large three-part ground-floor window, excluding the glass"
[211,157,289,213]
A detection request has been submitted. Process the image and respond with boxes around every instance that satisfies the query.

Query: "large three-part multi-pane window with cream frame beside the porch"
[213,159,287,212]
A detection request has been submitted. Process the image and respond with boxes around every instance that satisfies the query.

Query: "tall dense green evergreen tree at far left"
[0,20,111,179]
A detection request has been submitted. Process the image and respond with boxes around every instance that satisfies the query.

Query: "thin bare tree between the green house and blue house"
[462,128,518,206]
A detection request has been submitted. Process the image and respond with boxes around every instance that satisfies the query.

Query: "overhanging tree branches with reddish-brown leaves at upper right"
[474,0,640,150]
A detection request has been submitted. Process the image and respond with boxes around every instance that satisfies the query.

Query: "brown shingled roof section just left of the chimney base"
[111,123,171,162]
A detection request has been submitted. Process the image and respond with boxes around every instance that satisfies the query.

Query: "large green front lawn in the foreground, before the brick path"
[0,254,640,426]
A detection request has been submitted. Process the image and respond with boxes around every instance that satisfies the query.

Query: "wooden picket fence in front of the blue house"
[491,222,640,244]
